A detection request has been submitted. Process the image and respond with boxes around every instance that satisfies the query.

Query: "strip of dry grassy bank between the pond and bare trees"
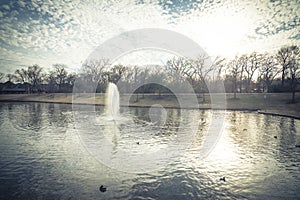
[0,93,300,119]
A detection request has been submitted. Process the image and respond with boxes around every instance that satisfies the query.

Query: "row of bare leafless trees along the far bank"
[0,45,300,101]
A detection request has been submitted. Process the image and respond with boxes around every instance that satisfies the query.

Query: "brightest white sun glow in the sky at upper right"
[181,5,253,57]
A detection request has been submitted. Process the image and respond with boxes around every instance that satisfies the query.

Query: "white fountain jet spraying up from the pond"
[105,83,120,120]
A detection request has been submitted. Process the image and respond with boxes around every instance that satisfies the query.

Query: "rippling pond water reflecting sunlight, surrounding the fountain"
[0,103,300,199]
